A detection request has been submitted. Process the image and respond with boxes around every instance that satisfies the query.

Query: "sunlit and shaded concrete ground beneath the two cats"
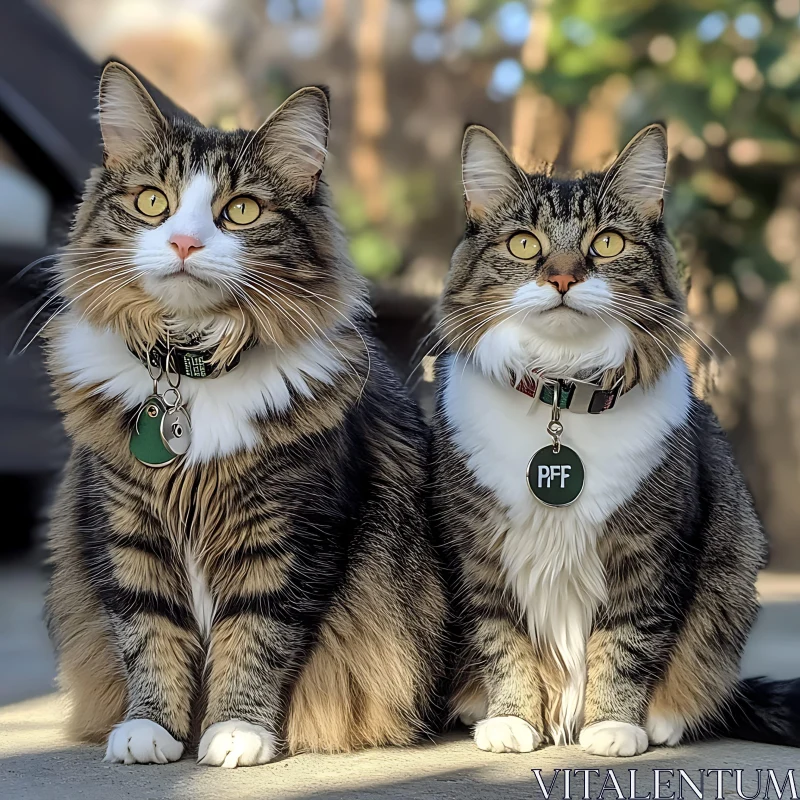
[0,564,800,800]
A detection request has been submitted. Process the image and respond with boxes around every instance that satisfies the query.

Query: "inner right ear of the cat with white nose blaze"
[257,86,330,195]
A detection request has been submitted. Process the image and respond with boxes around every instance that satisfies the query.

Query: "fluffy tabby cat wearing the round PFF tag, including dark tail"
[434,125,800,756]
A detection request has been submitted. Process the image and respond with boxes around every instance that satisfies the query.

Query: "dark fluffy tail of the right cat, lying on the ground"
[700,678,800,747]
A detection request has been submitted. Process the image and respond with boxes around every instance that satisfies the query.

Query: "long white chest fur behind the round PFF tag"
[444,359,690,744]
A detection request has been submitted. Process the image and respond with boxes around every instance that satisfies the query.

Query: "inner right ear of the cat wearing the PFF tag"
[600,123,667,219]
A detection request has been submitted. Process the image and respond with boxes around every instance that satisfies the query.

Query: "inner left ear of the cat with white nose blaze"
[98,61,167,165]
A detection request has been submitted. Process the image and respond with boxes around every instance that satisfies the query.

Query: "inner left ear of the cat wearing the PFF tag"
[461,125,520,221]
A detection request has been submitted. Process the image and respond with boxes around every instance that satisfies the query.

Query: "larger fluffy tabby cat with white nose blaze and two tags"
[47,63,444,767]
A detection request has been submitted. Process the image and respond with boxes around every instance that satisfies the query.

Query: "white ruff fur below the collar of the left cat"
[54,319,342,464]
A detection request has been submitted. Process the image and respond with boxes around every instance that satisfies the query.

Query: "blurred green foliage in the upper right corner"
[528,0,800,283]
